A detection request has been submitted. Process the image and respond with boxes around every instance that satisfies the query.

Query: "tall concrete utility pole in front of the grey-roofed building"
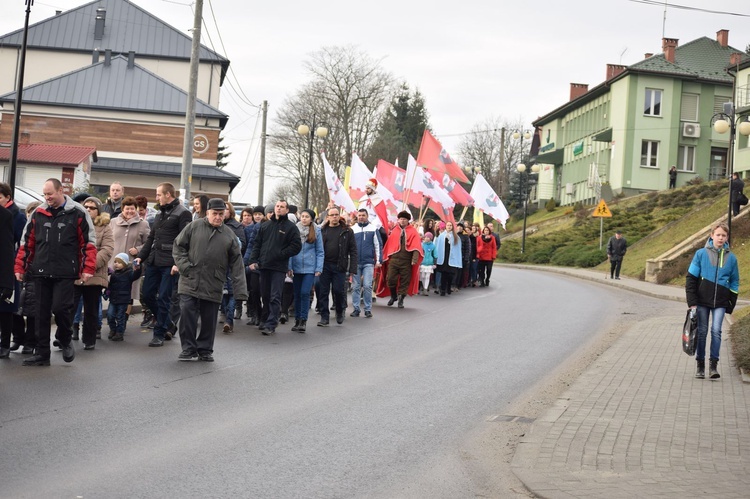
[180,0,203,205]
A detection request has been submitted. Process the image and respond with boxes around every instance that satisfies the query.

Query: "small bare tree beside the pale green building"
[458,116,531,199]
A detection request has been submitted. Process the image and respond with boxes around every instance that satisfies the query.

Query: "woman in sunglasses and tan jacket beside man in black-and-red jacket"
[73,196,115,350]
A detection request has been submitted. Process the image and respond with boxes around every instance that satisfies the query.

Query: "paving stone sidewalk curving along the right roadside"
[512,269,750,499]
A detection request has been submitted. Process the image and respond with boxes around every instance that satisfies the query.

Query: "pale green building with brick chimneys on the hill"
[533,30,749,205]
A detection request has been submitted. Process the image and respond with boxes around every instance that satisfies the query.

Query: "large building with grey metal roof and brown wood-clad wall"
[0,0,239,200]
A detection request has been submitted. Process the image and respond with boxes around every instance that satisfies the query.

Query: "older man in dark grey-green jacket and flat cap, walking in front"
[172,198,247,362]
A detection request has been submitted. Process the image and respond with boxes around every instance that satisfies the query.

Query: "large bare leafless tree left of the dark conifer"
[269,46,400,208]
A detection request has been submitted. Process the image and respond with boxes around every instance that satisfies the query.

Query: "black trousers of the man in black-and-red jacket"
[33,277,75,359]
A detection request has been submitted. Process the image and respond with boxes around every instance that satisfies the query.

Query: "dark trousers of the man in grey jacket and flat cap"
[179,294,221,354]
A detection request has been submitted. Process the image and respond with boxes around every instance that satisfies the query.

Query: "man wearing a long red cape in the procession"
[378,211,424,308]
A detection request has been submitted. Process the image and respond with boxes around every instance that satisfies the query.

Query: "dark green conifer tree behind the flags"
[363,83,430,167]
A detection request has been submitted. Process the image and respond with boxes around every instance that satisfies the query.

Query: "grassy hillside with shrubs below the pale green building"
[498,181,750,297]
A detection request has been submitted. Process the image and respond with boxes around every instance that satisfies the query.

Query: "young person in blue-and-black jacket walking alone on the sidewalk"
[685,222,740,379]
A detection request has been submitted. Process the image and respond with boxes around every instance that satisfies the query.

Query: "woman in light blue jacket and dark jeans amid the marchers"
[289,210,325,333]
